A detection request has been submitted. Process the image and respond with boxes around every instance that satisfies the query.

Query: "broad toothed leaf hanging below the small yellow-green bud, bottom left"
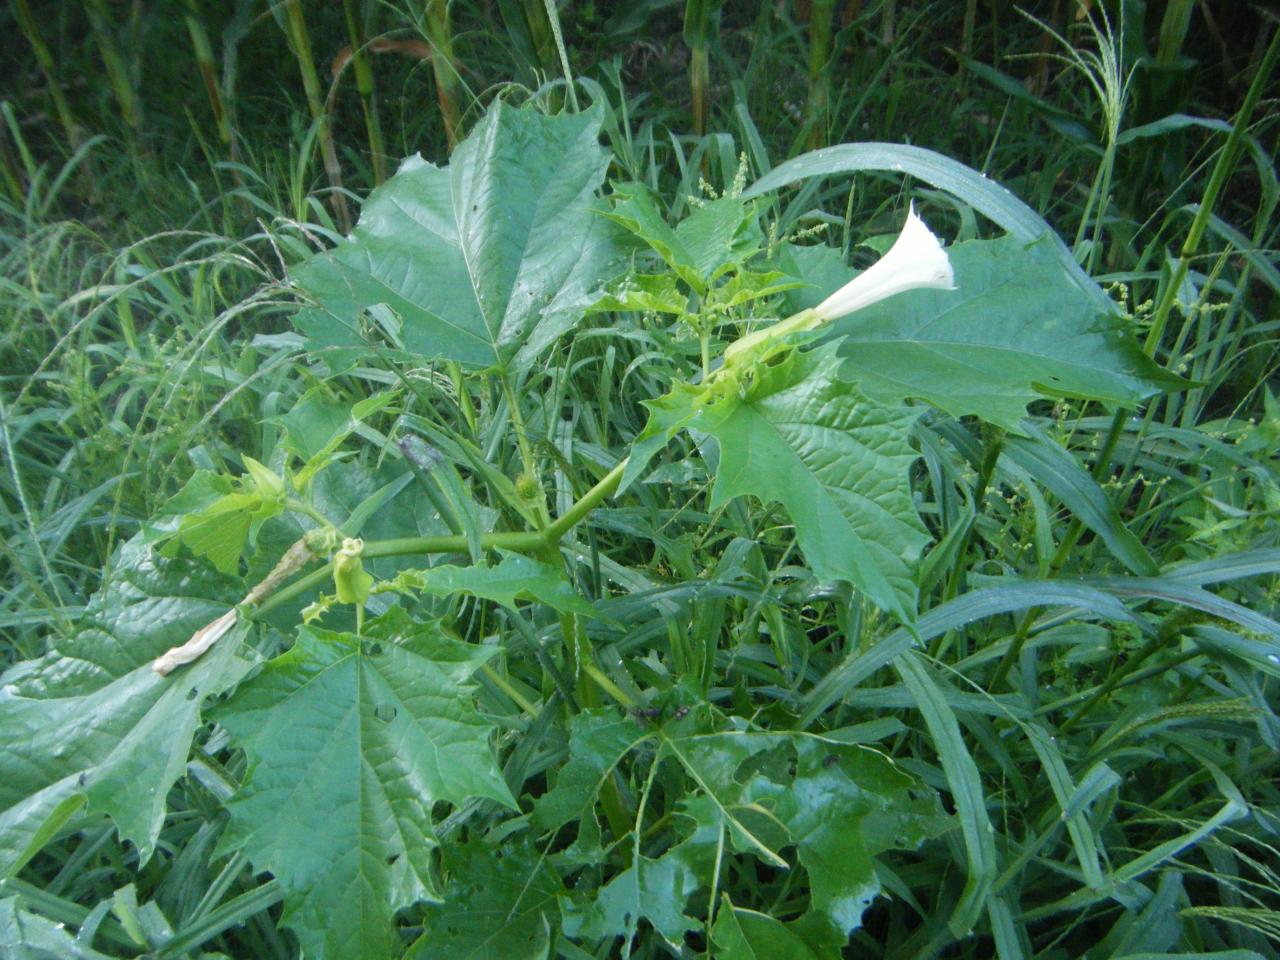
[218,611,515,960]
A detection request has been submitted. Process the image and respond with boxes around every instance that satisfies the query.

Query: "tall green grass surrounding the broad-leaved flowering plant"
[0,0,1280,957]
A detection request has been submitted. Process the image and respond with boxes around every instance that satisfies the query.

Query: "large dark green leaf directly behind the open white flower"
[829,237,1184,433]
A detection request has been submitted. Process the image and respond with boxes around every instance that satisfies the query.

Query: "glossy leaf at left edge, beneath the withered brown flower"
[0,536,248,876]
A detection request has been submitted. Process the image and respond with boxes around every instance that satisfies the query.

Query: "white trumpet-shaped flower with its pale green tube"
[724,205,955,366]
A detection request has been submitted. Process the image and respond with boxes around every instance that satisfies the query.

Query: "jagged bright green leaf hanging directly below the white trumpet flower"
[689,348,928,622]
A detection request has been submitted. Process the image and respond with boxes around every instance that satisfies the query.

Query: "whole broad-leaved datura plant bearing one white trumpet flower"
[0,102,1208,960]
